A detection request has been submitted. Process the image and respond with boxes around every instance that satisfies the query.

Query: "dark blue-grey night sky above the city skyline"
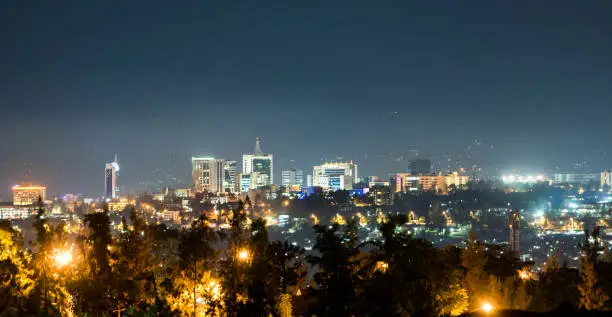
[0,0,612,200]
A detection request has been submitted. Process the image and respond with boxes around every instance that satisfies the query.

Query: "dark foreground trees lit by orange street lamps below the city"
[0,199,612,317]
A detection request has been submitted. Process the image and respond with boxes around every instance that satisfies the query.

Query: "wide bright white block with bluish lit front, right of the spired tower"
[312,161,358,190]
